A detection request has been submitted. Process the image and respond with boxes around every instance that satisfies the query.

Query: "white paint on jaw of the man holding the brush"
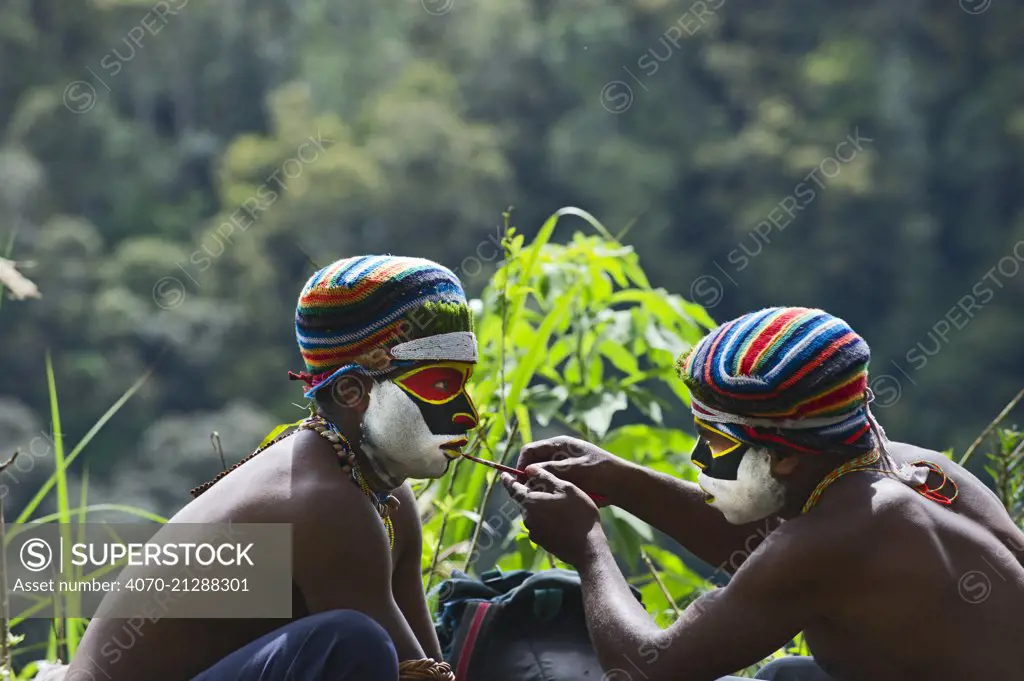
[697,448,785,525]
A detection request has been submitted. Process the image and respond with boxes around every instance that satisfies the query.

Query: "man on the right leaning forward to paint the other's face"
[504,308,1024,681]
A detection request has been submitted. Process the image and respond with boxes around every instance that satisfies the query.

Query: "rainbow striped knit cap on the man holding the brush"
[677,307,874,453]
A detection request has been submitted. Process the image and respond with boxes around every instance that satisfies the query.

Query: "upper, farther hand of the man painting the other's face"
[516,436,629,504]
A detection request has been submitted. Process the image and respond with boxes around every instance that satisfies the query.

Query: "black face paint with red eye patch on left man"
[393,361,480,435]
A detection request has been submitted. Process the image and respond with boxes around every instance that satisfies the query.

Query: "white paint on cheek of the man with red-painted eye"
[360,381,455,486]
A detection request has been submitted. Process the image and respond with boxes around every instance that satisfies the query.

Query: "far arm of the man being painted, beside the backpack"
[391,483,442,662]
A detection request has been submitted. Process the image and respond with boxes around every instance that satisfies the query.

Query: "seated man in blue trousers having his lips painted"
[67,256,478,681]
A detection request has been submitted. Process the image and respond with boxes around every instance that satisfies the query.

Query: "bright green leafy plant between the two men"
[420,209,714,586]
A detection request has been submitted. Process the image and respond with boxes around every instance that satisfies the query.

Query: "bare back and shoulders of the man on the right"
[793,444,1024,681]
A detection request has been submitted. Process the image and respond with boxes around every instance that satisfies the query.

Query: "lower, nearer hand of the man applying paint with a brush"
[502,466,601,565]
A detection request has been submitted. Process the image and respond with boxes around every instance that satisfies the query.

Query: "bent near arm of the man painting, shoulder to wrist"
[575,525,820,681]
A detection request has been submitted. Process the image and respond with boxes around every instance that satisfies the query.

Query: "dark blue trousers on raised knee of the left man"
[191,610,398,681]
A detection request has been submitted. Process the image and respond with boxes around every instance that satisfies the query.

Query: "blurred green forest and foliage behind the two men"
[0,0,1024,667]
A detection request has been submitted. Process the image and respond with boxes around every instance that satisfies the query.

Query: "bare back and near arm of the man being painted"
[68,432,422,681]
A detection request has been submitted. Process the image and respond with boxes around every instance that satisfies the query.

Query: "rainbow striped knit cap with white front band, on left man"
[289,255,477,397]
